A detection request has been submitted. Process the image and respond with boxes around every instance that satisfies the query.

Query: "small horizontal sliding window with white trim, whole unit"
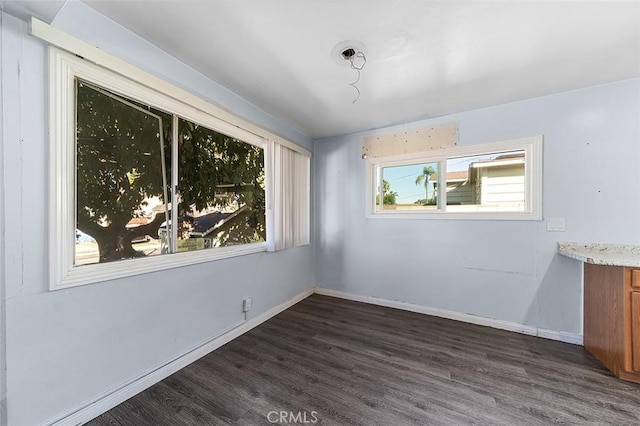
[367,138,542,220]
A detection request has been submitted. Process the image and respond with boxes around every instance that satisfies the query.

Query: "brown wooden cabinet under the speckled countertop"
[584,263,640,383]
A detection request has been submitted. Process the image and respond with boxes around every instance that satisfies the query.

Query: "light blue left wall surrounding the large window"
[0,7,313,425]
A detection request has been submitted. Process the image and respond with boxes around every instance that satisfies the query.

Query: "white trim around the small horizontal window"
[365,136,542,220]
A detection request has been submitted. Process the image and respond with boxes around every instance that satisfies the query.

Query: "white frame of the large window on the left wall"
[48,47,273,290]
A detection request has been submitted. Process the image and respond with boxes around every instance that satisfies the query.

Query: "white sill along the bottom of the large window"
[49,243,267,290]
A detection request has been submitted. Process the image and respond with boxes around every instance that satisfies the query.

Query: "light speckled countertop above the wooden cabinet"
[558,242,640,267]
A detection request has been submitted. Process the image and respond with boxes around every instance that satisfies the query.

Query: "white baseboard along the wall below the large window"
[50,289,313,426]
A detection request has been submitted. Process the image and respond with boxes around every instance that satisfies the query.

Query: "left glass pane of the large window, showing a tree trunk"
[74,79,171,265]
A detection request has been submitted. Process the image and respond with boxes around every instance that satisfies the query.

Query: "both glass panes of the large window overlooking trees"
[74,79,266,266]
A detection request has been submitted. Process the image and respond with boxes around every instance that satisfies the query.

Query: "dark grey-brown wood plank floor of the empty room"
[89,295,640,426]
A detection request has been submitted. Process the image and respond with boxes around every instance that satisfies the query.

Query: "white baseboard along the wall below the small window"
[314,287,582,345]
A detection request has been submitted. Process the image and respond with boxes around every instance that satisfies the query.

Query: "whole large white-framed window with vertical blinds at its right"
[50,50,309,289]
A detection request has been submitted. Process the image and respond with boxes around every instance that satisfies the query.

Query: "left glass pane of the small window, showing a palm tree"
[376,162,439,211]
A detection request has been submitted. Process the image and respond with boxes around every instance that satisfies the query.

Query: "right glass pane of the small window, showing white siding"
[445,150,525,212]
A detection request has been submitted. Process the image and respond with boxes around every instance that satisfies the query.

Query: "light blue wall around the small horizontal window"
[314,80,640,333]
